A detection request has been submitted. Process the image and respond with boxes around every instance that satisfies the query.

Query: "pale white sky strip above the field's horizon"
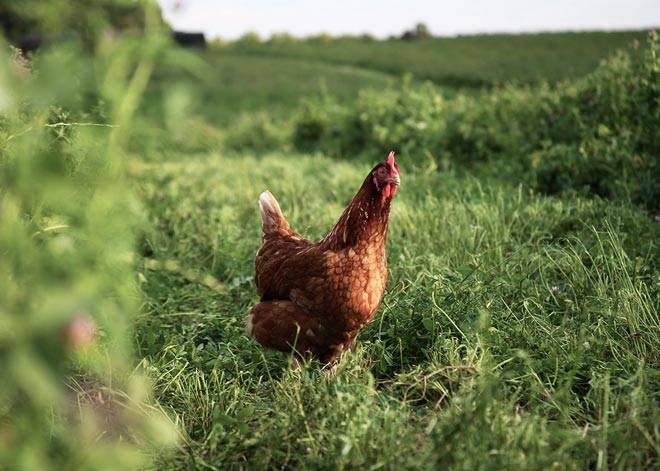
[158,0,660,39]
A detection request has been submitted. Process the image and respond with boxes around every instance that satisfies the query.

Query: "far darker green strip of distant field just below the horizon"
[226,31,647,87]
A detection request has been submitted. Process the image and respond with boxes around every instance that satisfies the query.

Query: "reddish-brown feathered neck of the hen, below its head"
[321,180,391,250]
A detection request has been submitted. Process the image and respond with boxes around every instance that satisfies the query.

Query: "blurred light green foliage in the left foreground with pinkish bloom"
[0,1,174,470]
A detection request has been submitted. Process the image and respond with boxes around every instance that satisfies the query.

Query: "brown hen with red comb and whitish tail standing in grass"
[246,152,400,363]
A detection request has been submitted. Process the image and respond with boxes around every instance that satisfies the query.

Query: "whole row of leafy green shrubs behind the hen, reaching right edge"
[294,35,660,209]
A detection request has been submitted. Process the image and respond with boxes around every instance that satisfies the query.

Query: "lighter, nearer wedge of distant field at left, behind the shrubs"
[148,51,394,124]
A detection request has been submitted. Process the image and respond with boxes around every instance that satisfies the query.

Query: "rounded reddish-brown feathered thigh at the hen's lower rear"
[246,301,319,355]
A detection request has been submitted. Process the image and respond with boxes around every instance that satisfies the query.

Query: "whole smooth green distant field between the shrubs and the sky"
[146,31,646,126]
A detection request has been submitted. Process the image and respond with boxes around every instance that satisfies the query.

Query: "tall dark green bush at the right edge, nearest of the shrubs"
[528,34,660,211]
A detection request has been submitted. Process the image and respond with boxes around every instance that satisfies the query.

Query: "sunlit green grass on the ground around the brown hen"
[132,153,660,469]
